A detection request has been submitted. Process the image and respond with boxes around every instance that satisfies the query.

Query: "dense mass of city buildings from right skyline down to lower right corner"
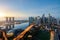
[29,14,60,40]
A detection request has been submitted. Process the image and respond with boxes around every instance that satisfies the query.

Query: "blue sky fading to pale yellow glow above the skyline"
[0,0,60,17]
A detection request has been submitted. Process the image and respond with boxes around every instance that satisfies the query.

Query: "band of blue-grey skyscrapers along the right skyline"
[29,14,60,25]
